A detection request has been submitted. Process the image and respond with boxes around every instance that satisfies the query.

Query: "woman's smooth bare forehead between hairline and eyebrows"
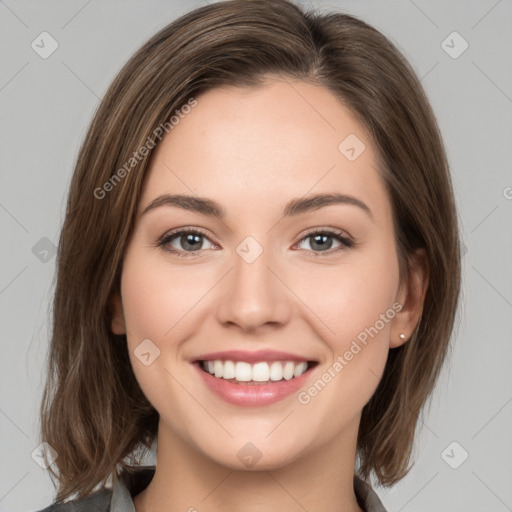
[139,80,389,222]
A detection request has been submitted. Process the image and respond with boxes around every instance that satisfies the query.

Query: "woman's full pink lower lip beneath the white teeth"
[194,363,314,407]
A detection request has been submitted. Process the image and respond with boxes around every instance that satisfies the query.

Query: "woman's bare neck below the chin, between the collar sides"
[134,418,362,512]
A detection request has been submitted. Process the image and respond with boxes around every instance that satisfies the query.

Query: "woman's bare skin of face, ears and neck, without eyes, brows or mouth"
[112,77,428,512]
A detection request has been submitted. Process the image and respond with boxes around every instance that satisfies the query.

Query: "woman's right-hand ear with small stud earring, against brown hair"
[389,249,429,348]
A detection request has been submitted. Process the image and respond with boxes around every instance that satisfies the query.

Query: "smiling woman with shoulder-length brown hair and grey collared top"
[36,0,460,512]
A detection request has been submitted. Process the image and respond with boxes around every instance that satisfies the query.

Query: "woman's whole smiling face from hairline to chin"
[112,81,416,469]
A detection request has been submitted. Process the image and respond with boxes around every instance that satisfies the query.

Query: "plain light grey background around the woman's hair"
[0,0,512,512]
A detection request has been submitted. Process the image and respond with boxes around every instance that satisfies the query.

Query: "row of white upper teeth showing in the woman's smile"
[202,360,308,382]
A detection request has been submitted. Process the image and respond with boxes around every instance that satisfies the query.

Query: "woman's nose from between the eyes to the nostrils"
[217,243,293,331]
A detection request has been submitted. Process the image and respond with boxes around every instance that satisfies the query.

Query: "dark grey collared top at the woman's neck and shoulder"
[38,466,386,512]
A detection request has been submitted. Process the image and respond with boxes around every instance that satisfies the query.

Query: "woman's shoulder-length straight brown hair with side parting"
[41,0,460,501]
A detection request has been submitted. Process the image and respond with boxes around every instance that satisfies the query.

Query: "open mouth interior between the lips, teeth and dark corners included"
[195,359,318,386]
